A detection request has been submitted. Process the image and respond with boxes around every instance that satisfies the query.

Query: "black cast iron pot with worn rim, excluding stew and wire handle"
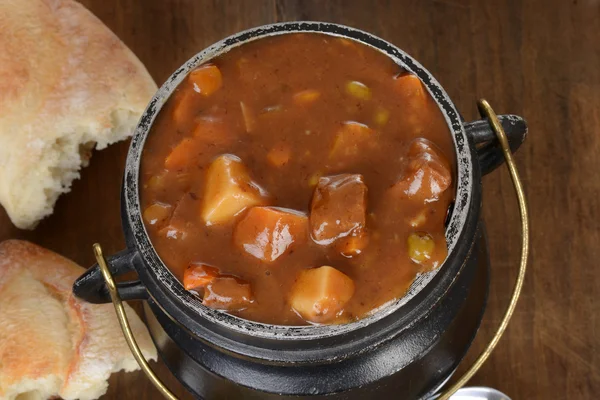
[73,22,527,399]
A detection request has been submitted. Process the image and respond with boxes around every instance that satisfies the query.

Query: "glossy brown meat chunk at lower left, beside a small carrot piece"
[202,276,254,311]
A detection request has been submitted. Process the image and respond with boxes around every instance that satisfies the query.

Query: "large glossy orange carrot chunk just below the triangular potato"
[233,207,308,263]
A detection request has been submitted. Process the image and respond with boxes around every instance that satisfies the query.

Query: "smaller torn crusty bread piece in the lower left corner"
[0,240,156,400]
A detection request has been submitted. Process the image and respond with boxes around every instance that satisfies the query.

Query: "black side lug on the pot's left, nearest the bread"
[73,249,148,304]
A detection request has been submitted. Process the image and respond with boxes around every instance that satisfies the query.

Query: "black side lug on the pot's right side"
[464,115,527,175]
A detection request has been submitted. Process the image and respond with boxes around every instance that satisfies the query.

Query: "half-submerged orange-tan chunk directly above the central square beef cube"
[329,121,375,161]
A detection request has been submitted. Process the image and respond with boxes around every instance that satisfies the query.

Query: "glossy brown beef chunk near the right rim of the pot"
[390,138,452,203]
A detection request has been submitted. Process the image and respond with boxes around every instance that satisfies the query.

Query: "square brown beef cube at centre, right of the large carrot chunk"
[310,174,367,245]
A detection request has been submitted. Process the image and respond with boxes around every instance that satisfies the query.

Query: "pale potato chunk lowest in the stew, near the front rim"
[290,266,354,323]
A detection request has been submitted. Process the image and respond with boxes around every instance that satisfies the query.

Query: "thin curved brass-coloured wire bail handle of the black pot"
[94,99,529,400]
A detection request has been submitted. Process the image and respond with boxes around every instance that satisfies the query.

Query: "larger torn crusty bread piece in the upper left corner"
[0,0,156,229]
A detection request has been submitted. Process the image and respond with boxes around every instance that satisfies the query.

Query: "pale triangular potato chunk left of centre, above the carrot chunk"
[201,154,267,225]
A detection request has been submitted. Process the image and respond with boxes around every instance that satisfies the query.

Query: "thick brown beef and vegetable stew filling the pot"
[141,34,454,325]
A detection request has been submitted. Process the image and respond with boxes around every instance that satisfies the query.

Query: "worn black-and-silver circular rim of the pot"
[123,22,474,340]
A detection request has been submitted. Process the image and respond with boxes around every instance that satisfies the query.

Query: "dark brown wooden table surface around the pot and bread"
[0,0,600,400]
